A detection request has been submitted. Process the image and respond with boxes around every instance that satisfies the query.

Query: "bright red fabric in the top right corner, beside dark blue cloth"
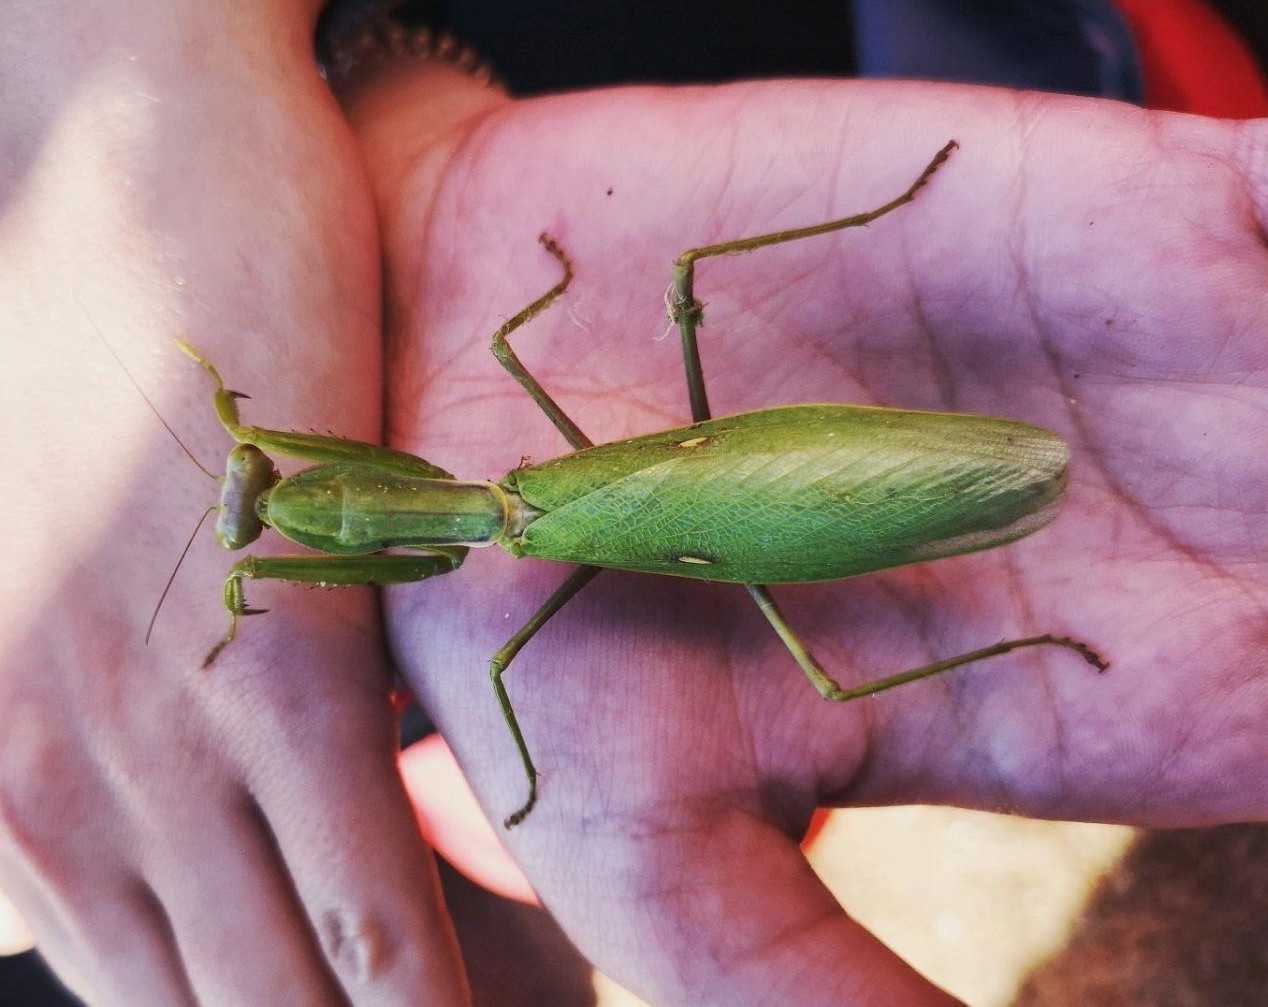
[1115,0,1268,119]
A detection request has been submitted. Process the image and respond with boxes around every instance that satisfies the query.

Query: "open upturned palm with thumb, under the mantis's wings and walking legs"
[345,67,1268,1007]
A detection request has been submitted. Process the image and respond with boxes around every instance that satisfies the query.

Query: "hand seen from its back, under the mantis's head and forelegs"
[0,3,467,1007]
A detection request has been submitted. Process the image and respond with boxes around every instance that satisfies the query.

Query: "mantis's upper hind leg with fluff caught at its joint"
[670,140,959,422]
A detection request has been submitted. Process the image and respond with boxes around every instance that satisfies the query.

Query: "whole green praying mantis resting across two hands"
[173,141,1107,828]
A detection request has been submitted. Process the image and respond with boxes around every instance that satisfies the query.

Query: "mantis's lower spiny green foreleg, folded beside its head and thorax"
[203,548,467,668]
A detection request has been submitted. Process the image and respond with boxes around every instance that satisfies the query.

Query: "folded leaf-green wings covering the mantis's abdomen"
[506,405,1069,583]
